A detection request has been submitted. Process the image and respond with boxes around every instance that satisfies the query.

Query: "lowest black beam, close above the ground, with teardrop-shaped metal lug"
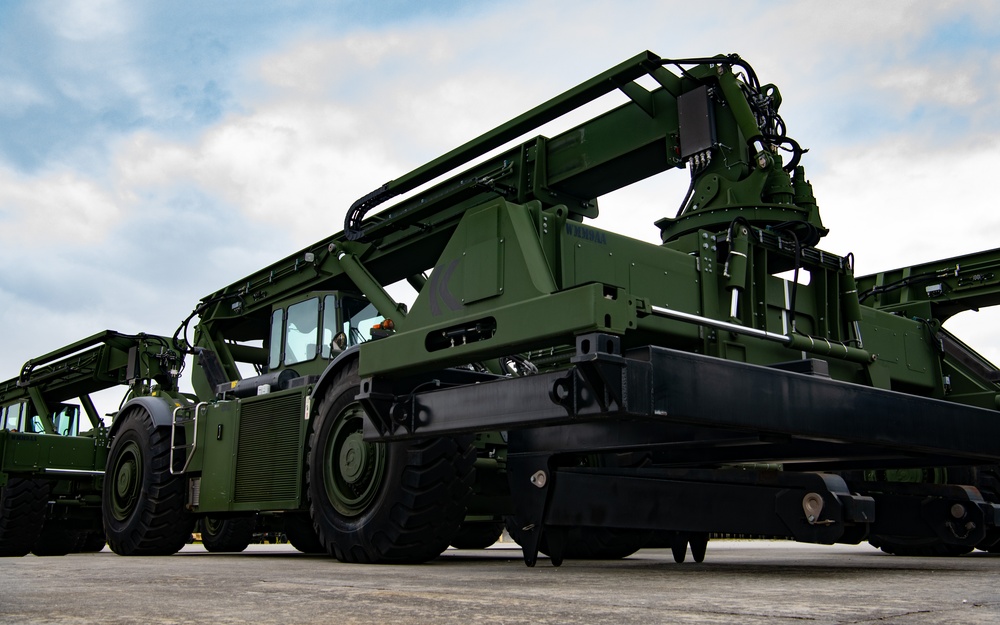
[544,469,875,544]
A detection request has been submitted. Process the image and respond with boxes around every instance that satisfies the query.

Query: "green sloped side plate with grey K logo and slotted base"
[361,200,640,375]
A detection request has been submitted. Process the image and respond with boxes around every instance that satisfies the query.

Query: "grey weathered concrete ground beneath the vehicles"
[0,541,1000,625]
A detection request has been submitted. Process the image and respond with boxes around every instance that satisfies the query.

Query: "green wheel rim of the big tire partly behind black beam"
[323,404,386,517]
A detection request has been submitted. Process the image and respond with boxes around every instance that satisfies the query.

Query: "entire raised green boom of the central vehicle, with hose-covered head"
[186,52,825,379]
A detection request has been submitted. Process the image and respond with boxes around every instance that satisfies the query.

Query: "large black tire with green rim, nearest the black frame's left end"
[307,363,475,563]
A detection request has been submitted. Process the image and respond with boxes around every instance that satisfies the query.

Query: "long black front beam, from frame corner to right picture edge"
[636,348,1000,462]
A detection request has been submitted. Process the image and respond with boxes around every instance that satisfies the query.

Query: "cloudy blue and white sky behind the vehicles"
[0,0,1000,400]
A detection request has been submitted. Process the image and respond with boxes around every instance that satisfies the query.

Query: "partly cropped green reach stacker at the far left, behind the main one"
[0,331,183,556]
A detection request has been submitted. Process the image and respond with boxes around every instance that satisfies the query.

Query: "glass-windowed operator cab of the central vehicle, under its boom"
[267,291,383,373]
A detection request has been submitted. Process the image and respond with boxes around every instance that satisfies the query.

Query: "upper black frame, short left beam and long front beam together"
[361,347,1000,463]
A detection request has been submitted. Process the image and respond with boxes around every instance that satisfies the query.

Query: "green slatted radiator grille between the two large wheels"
[233,393,303,502]
